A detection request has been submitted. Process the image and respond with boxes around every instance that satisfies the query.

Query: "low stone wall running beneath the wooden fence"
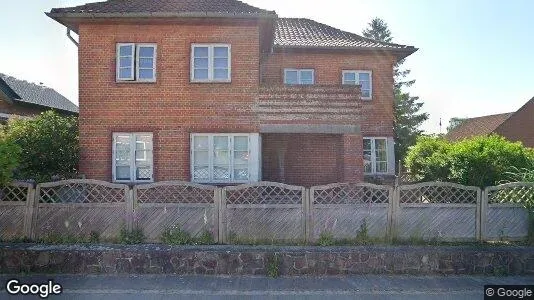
[0,244,534,276]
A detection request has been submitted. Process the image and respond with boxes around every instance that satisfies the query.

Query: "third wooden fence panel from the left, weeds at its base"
[134,181,219,242]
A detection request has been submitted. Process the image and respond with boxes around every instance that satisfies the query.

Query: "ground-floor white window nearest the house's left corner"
[113,133,153,182]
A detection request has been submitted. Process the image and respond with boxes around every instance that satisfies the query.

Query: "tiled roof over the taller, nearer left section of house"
[50,0,276,17]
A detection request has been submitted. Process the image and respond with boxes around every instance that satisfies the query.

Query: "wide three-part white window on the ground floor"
[191,133,259,183]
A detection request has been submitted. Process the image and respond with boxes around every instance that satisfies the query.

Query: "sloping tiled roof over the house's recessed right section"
[274,18,417,55]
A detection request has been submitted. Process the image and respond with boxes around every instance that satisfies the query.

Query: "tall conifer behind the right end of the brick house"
[362,18,428,166]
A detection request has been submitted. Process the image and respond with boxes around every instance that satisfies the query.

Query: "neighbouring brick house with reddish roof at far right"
[445,98,534,148]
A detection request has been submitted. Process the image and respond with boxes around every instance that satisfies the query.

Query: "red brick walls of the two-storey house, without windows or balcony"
[78,21,394,185]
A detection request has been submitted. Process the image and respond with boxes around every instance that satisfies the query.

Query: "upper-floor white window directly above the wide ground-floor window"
[191,44,231,82]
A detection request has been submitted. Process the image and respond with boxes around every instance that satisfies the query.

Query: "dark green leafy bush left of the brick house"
[5,111,79,182]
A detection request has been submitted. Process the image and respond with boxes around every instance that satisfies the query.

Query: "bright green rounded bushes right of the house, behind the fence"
[405,135,534,187]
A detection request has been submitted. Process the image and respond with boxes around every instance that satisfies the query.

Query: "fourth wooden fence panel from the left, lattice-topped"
[222,181,307,243]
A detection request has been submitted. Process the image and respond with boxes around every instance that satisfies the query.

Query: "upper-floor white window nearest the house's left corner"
[117,43,156,82]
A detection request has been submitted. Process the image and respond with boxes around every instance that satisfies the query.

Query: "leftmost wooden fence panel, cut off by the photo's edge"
[0,182,33,240]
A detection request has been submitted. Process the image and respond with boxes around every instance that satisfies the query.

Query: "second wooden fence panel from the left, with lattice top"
[33,179,129,239]
